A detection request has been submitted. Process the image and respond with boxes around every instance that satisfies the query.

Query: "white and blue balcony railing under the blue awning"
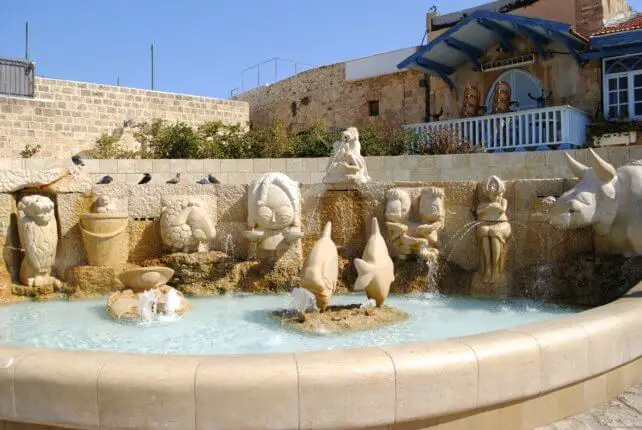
[404,106,589,152]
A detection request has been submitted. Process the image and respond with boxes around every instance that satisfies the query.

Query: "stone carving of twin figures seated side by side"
[385,187,444,260]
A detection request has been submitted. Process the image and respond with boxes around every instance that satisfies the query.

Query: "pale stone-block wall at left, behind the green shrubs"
[0,77,249,158]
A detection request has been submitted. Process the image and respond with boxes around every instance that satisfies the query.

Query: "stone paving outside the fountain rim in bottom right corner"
[538,384,642,430]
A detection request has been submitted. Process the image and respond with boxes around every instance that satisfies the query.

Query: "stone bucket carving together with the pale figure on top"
[80,195,129,267]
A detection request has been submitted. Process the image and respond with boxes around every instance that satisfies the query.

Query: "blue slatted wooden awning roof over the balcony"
[397,10,587,89]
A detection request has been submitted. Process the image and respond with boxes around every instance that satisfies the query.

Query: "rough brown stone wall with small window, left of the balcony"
[235,63,426,131]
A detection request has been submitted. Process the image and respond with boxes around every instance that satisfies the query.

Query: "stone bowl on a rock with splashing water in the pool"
[107,267,190,320]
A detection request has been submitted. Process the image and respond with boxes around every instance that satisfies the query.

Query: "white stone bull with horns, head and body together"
[550,149,642,256]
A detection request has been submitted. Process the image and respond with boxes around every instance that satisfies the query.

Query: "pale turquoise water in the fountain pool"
[0,294,579,354]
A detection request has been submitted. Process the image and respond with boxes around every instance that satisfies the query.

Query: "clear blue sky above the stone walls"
[0,0,642,98]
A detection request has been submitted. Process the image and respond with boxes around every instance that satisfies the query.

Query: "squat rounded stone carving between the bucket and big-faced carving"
[160,198,216,252]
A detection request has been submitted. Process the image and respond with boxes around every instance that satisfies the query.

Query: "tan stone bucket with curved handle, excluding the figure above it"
[80,213,127,267]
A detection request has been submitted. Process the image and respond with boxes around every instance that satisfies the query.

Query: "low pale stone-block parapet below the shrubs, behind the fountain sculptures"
[0,145,642,184]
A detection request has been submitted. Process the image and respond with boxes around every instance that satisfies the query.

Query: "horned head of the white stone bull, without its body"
[550,149,618,235]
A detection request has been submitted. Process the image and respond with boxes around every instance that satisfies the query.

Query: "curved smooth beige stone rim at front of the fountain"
[0,282,642,429]
